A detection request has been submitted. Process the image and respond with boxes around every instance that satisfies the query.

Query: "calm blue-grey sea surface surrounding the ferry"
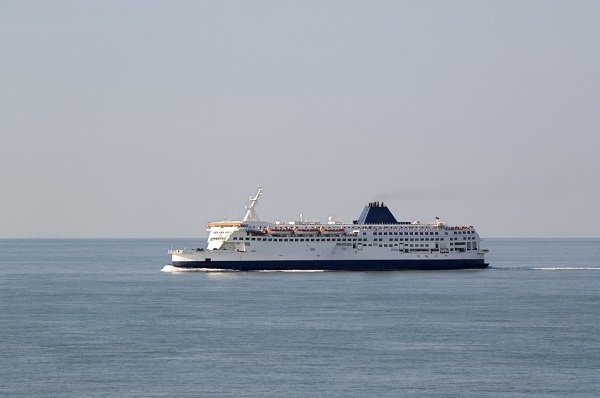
[0,239,600,398]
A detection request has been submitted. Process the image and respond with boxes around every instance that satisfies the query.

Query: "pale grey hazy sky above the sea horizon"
[0,0,600,238]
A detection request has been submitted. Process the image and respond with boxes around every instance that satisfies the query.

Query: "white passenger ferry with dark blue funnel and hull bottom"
[168,188,488,271]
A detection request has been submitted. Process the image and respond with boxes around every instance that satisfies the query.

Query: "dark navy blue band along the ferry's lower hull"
[172,260,488,271]
